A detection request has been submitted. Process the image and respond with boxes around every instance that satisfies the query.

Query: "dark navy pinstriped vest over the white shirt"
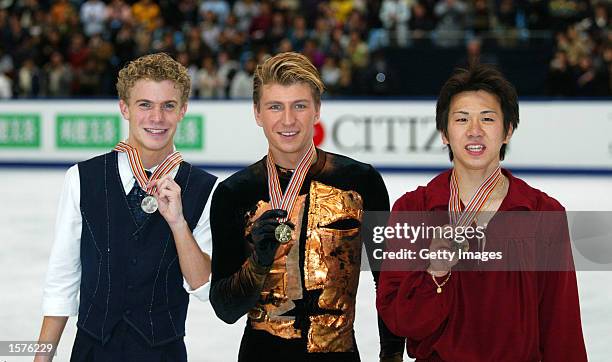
[77,152,216,346]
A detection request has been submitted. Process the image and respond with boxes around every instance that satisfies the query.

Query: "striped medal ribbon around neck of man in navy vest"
[113,141,183,195]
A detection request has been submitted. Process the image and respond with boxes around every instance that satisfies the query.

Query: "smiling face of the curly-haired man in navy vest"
[119,79,187,167]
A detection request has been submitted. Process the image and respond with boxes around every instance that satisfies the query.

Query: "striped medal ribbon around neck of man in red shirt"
[448,166,502,227]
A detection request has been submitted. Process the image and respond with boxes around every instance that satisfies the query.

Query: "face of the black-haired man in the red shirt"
[442,90,512,174]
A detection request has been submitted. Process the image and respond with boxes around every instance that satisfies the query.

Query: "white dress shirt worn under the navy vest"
[43,153,219,316]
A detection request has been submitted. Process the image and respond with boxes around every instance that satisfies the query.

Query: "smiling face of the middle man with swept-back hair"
[254,83,320,169]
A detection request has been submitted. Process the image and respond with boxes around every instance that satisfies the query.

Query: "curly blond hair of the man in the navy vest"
[117,53,191,104]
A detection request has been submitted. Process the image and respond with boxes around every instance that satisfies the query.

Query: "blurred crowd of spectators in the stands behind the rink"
[0,0,612,99]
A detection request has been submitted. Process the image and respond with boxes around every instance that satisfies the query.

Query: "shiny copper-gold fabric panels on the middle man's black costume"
[245,181,363,352]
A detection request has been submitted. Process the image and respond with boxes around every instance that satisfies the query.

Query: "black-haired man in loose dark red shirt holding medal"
[377,65,587,362]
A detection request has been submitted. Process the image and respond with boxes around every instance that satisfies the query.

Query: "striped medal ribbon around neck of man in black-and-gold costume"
[266,143,316,223]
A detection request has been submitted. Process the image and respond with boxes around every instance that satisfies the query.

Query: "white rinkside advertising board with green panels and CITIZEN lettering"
[0,100,612,174]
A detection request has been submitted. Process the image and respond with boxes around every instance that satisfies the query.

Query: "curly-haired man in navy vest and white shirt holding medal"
[35,53,216,362]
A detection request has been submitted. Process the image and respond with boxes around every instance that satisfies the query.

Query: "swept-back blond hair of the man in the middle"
[253,52,325,109]
